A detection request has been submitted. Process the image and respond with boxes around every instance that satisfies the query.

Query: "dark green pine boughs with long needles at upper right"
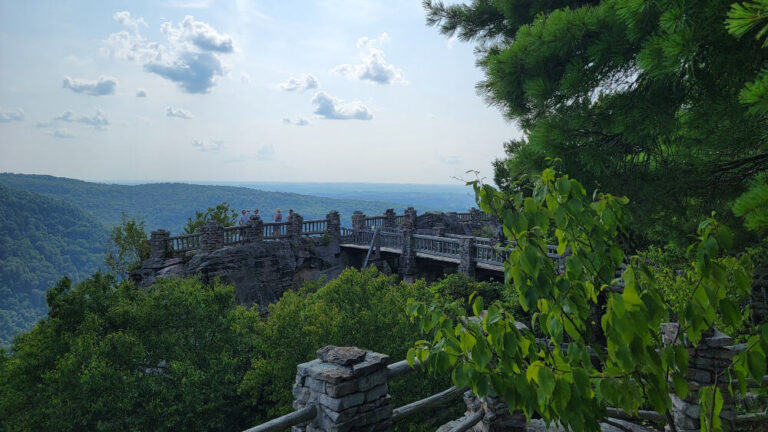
[425,0,768,246]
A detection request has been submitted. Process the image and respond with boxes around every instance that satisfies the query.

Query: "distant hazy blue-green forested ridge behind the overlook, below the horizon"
[0,173,403,234]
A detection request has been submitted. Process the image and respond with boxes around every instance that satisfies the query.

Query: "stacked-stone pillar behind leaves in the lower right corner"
[661,323,738,432]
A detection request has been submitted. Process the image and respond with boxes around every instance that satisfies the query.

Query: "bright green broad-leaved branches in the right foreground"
[408,169,768,430]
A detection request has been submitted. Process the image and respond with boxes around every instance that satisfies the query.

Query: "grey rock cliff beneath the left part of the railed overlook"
[131,240,341,309]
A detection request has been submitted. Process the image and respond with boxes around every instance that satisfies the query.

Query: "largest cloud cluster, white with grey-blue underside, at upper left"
[101,15,235,94]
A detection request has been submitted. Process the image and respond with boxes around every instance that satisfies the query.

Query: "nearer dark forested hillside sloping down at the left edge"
[0,185,107,346]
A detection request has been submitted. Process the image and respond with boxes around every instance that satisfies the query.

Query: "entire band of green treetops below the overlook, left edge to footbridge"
[0,269,508,431]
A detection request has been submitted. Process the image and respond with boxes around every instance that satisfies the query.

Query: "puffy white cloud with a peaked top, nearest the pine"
[331,33,408,84]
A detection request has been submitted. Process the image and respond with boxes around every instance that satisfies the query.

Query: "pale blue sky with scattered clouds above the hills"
[0,0,521,184]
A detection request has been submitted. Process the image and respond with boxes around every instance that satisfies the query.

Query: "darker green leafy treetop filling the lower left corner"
[0,274,259,431]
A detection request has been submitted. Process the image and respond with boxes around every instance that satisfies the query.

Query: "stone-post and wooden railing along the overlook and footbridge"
[144,207,560,278]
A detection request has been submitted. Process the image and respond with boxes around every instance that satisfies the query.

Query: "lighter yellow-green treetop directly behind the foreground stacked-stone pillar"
[242,268,464,429]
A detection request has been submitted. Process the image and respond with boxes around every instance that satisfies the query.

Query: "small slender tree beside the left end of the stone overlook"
[104,213,149,277]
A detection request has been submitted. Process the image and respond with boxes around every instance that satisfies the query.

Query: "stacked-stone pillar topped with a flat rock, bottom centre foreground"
[293,345,392,432]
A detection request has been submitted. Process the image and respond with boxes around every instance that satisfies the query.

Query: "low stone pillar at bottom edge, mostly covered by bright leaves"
[456,391,527,432]
